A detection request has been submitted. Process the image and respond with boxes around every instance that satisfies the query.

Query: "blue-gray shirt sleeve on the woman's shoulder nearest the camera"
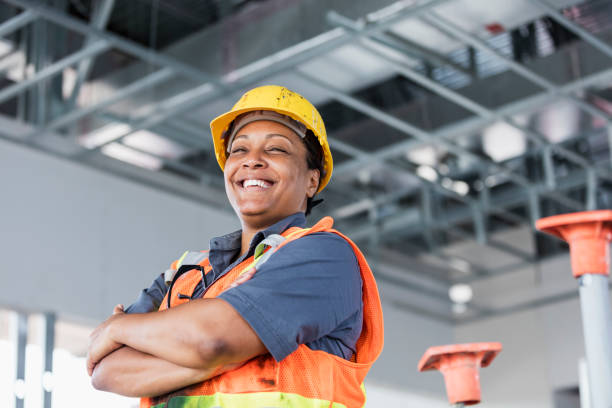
[219,232,362,361]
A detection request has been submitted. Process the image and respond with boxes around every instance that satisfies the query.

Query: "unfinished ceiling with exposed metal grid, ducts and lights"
[0,0,612,322]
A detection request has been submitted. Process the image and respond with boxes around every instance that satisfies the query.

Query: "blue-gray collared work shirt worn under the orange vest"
[126,212,363,361]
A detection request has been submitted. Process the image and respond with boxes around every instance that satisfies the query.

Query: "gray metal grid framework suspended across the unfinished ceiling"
[0,0,612,322]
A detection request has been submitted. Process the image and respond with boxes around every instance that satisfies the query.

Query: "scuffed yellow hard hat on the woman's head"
[210,85,334,193]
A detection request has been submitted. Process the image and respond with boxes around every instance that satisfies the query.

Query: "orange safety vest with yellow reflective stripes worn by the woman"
[140,217,383,408]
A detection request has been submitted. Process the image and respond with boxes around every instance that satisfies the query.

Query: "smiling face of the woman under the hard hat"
[224,120,319,229]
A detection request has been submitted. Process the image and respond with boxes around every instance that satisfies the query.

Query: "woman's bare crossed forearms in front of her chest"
[87,299,267,397]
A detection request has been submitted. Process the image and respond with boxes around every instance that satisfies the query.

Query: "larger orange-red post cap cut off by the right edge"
[536,210,612,278]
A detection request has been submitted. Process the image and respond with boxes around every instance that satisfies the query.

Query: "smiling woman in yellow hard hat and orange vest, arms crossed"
[87,86,383,408]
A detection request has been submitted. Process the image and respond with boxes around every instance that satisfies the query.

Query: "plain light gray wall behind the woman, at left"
[0,141,238,323]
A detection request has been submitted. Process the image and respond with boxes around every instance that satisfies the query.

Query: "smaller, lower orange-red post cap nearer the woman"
[419,342,502,405]
